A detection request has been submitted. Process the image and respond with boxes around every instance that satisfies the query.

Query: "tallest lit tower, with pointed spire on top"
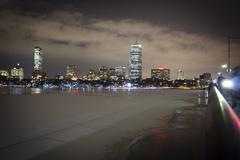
[128,42,142,80]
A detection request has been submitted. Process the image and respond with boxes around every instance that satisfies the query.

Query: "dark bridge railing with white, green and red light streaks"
[206,86,240,160]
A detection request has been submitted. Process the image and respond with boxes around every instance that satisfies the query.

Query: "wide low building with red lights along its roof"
[151,68,170,80]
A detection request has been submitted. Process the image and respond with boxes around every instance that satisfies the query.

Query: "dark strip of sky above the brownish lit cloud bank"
[2,0,240,36]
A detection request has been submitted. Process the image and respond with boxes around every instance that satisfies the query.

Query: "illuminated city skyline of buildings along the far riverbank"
[1,44,211,80]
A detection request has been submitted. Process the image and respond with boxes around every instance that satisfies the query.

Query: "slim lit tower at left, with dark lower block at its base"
[32,47,47,83]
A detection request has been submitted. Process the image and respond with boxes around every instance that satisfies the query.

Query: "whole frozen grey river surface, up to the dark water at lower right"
[0,89,205,160]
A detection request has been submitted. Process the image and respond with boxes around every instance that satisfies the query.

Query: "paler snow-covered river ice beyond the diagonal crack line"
[0,89,199,159]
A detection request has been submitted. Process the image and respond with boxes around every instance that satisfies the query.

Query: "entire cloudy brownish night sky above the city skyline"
[0,0,240,78]
